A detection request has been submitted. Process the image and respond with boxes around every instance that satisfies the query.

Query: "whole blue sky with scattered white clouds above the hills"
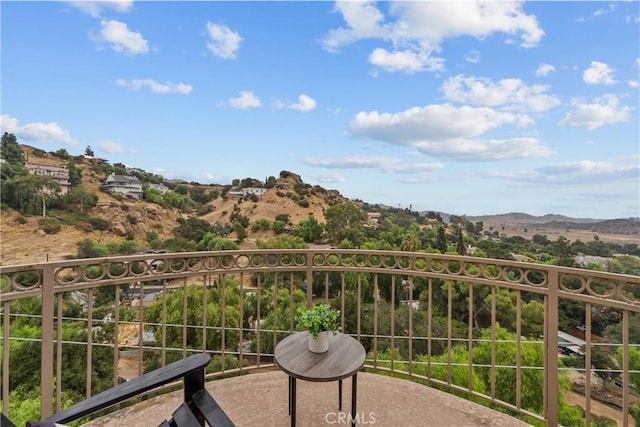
[0,1,640,219]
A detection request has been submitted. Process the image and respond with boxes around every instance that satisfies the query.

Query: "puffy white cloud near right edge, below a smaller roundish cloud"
[558,94,631,130]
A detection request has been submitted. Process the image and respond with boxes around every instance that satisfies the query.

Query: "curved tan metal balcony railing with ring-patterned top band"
[0,249,640,426]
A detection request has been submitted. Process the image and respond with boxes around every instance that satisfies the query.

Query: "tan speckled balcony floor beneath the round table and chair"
[81,368,529,427]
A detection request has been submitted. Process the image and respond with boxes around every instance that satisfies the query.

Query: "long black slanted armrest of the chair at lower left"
[43,353,211,423]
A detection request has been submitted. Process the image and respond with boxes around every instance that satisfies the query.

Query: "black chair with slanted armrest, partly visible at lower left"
[1,353,234,427]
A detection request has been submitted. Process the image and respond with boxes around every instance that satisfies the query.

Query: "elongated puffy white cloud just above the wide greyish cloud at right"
[442,75,560,112]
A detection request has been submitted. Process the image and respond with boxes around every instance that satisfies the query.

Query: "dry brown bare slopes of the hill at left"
[0,146,349,265]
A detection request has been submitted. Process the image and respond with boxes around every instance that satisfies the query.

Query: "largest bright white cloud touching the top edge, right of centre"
[322,1,544,72]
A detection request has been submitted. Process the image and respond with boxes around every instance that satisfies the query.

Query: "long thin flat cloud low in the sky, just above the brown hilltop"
[303,156,444,174]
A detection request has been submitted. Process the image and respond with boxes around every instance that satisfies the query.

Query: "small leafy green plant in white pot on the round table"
[296,304,340,353]
